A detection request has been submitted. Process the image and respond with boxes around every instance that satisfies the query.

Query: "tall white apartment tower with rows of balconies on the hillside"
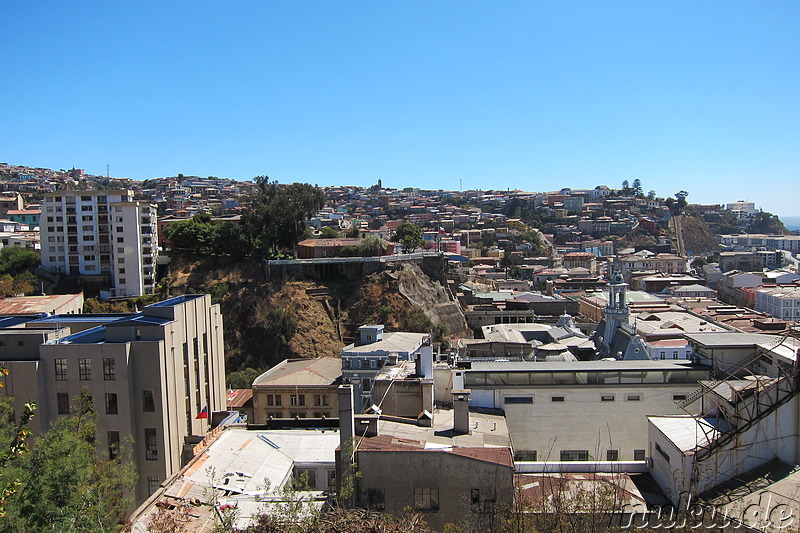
[40,190,158,296]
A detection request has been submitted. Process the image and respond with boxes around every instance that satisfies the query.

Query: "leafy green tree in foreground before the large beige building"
[4,389,136,532]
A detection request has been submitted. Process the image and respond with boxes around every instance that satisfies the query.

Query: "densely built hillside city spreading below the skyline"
[0,163,800,533]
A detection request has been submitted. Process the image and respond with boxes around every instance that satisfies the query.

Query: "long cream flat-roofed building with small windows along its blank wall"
[460,361,710,462]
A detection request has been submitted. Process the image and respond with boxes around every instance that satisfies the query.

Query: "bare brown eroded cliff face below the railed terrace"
[170,255,470,371]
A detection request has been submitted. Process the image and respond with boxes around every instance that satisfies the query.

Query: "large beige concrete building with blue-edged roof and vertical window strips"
[0,295,226,504]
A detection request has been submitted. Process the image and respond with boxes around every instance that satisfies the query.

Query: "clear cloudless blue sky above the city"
[0,0,800,216]
